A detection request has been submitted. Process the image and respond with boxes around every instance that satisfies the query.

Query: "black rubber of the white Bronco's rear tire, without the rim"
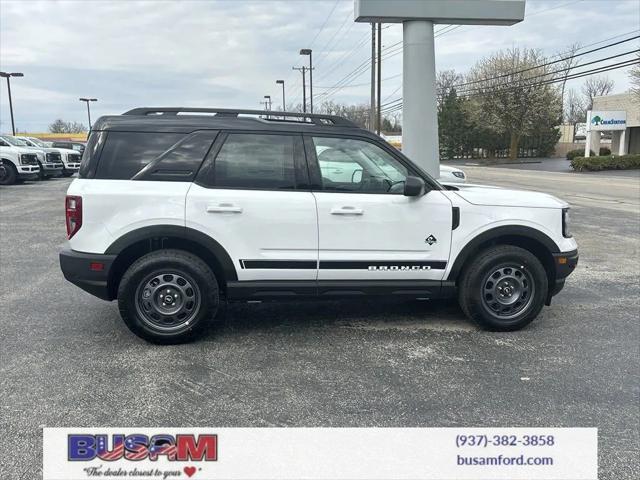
[118,251,219,344]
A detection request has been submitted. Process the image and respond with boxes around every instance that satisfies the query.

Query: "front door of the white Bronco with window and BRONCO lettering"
[306,136,452,281]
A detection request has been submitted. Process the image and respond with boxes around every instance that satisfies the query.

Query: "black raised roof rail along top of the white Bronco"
[123,107,357,127]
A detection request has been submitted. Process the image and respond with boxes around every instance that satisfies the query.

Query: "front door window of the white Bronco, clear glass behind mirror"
[313,137,410,194]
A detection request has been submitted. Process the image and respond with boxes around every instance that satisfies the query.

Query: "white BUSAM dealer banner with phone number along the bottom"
[43,428,598,480]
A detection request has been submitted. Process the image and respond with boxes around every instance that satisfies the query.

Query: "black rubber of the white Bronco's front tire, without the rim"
[461,247,549,331]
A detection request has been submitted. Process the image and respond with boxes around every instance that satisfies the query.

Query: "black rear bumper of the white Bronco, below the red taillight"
[60,248,116,300]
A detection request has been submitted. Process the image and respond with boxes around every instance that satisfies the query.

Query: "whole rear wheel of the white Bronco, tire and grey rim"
[118,249,220,344]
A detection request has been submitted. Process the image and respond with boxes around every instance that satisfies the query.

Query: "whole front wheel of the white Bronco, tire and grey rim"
[458,245,549,332]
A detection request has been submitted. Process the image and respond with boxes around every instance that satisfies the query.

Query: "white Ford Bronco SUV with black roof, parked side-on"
[60,108,578,343]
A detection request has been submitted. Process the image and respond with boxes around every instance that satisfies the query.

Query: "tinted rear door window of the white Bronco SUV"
[214,133,296,190]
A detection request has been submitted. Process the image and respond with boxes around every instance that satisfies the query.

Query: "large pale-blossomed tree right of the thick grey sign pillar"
[463,48,561,159]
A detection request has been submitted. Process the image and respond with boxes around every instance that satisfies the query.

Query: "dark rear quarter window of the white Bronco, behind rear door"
[95,132,185,180]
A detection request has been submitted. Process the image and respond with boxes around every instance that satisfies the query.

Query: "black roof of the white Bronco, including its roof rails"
[92,107,378,138]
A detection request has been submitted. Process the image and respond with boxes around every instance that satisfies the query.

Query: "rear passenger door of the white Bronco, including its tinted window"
[186,132,318,281]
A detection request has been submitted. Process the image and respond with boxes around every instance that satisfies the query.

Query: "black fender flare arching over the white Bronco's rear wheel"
[104,225,238,281]
